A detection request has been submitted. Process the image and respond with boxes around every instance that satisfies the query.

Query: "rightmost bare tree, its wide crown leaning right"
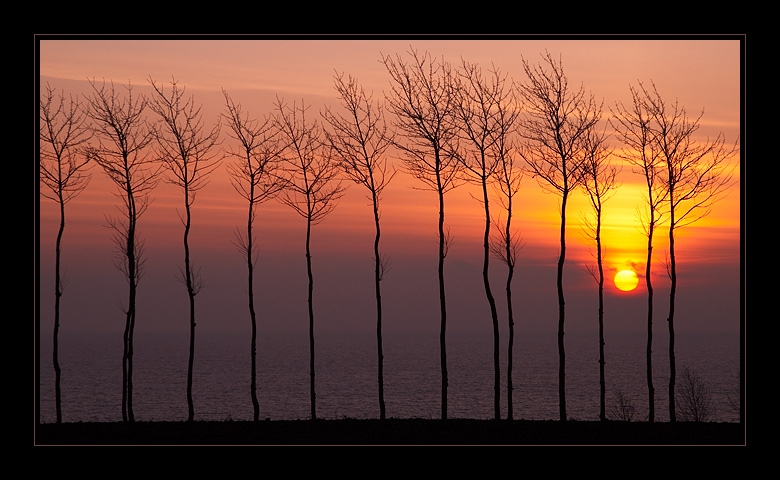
[641,80,739,422]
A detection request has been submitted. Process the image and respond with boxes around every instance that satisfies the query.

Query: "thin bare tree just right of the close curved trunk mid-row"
[490,103,523,420]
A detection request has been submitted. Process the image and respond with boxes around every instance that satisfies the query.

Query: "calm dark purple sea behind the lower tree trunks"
[39,332,740,423]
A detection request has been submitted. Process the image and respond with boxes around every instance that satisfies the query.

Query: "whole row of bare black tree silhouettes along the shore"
[38,50,739,422]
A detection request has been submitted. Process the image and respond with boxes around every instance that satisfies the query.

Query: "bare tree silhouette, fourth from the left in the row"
[223,90,287,421]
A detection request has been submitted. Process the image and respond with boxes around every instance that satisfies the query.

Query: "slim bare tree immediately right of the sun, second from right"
[610,83,667,423]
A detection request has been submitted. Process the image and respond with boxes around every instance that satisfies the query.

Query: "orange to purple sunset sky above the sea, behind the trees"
[36,37,743,344]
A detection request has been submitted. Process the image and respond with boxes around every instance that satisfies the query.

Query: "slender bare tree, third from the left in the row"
[149,78,220,422]
